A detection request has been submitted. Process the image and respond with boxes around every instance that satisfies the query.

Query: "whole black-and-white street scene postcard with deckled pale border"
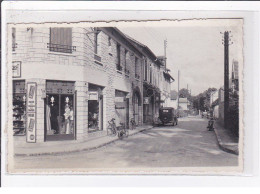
[5,18,243,175]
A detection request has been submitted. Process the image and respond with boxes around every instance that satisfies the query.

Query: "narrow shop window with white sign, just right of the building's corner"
[88,84,104,132]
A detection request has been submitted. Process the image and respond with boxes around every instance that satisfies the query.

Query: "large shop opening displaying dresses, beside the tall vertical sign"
[45,81,76,141]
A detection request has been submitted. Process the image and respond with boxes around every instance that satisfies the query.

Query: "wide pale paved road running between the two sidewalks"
[15,117,238,168]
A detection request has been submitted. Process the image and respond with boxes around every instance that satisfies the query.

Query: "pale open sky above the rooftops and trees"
[118,19,243,95]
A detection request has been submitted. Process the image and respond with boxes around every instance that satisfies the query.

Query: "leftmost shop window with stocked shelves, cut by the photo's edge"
[13,80,26,135]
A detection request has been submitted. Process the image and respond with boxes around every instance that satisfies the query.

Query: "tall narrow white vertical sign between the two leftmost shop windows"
[26,82,37,143]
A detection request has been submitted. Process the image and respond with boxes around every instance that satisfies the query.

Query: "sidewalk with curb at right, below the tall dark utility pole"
[214,122,239,155]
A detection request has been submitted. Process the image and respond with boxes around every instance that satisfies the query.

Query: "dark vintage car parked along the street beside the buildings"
[155,107,178,126]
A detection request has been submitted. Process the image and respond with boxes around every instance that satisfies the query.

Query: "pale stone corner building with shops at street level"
[11,25,143,143]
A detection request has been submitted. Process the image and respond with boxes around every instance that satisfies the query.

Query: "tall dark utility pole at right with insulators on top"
[222,31,233,128]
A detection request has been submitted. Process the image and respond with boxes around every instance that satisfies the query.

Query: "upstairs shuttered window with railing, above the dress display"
[47,28,76,53]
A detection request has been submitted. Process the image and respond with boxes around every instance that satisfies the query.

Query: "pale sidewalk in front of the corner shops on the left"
[14,125,153,156]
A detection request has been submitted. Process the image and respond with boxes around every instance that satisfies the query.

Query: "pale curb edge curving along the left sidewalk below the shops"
[14,127,153,156]
